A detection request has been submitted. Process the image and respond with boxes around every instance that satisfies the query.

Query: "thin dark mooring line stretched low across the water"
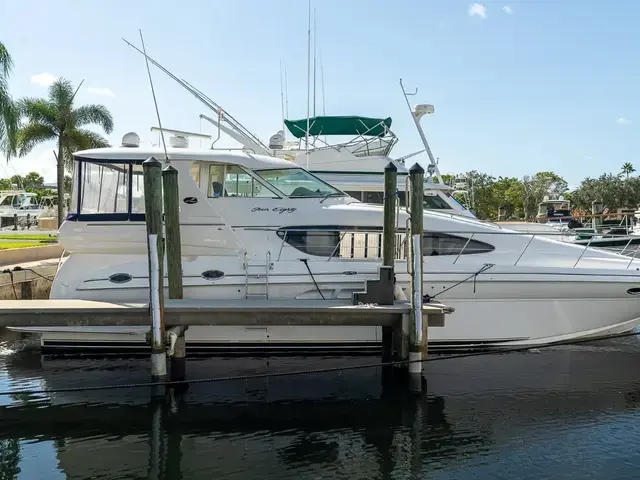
[0,332,640,397]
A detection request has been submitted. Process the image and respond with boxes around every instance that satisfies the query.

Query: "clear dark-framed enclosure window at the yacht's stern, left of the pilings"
[80,162,129,214]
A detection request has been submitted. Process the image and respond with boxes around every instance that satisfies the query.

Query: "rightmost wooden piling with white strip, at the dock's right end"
[409,163,427,391]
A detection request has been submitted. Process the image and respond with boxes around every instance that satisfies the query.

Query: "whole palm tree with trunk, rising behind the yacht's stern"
[18,78,113,226]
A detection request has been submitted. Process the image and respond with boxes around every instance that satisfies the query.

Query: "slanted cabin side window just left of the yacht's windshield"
[208,165,279,198]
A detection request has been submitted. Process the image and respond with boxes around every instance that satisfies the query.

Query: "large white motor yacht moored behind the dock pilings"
[14,134,640,353]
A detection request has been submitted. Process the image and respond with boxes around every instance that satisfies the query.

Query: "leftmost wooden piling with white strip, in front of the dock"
[142,157,167,381]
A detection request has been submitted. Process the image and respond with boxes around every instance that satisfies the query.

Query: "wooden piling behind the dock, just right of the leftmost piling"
[162,165,186,381]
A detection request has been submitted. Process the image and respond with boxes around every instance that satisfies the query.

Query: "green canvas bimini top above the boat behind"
[284,115,391,138]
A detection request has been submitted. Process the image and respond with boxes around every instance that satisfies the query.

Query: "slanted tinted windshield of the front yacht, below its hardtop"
[254,168,347,198]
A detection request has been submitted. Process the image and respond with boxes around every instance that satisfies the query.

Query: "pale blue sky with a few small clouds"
[0,0,640,186]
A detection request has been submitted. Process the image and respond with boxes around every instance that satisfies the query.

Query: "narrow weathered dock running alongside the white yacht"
[0,299,450,328]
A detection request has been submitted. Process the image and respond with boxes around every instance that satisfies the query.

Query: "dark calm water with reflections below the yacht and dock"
[0,337,640,480]
